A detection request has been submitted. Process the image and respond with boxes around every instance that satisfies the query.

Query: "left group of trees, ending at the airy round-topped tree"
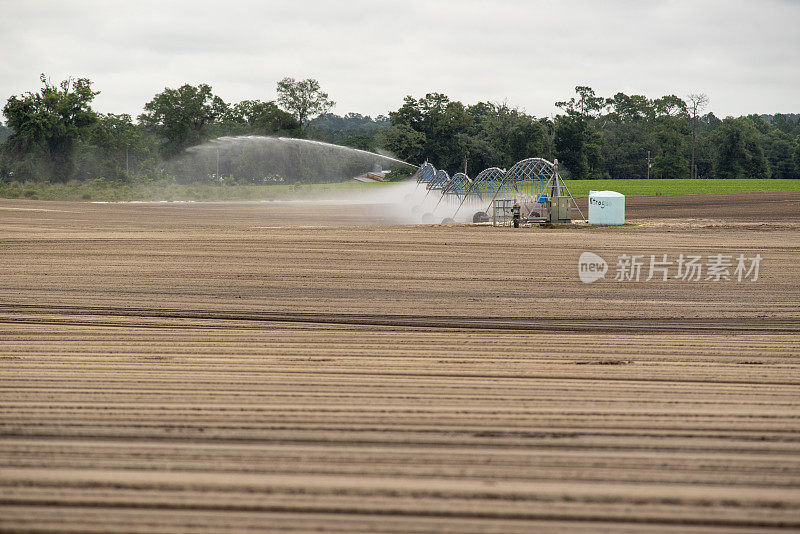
[0,75,334,182]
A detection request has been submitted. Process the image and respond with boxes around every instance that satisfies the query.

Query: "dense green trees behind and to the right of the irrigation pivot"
[381,86,800,179]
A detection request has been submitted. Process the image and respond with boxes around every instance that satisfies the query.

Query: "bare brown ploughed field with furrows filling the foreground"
[0,193,800,533]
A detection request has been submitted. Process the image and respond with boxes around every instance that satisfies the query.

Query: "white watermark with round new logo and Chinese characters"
[578,252,763,284]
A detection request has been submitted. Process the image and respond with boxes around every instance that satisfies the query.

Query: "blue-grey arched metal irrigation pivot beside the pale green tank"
[413,158,586,224]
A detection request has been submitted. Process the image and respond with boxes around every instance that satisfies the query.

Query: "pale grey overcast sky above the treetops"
[0,0,800,121]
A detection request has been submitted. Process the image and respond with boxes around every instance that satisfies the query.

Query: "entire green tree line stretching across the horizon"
[0,75,800,181]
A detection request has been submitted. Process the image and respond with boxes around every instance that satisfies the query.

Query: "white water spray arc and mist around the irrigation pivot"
[165,136,582,224]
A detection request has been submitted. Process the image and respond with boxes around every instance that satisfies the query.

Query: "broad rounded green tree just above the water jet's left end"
[139,83,229,157]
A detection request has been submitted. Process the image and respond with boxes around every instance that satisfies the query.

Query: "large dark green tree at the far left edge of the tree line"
[3,74,100,181]
